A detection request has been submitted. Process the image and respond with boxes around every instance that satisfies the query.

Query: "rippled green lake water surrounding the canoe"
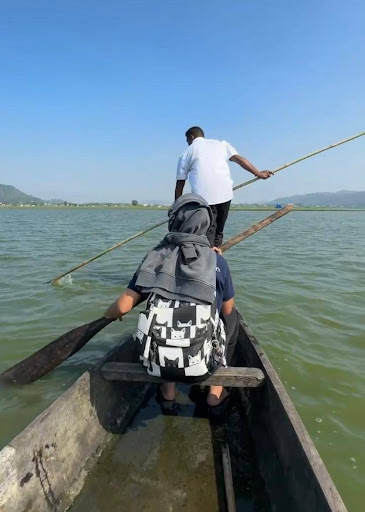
[0,209,365,512]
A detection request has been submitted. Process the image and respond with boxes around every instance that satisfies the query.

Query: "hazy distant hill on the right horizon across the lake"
[268,190,365,208]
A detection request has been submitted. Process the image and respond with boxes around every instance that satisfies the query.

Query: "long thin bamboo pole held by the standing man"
[50,132,365,284]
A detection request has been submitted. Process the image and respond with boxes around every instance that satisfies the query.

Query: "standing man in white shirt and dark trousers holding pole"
[175,126,273,247]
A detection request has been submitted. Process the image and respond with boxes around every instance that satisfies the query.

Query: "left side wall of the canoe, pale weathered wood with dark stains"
[0,337,145,512]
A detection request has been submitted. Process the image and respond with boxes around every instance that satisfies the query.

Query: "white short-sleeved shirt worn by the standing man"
[176,137,238,204]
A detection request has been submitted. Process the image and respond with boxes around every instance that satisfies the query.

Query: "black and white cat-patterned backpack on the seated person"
[135,293,226,382]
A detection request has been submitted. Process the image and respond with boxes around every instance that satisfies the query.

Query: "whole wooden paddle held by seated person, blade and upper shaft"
[0,205,293,384]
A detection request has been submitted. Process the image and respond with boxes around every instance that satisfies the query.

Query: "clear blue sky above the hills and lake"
[0,0,365,202]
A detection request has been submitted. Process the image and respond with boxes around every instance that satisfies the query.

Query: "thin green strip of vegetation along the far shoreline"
[0,203,365,212]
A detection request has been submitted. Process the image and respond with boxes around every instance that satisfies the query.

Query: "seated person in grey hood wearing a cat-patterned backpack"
[104,194,238,407]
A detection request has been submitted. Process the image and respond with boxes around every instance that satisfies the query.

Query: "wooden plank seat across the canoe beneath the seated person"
[100,362,265,388]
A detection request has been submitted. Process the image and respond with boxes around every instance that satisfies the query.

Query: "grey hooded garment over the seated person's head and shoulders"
[136,194,216,304]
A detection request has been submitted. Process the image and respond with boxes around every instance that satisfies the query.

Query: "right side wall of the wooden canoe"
[238,320,346,512]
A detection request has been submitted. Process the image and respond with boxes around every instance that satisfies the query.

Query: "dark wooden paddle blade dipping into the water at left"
[0,317,113,384]
